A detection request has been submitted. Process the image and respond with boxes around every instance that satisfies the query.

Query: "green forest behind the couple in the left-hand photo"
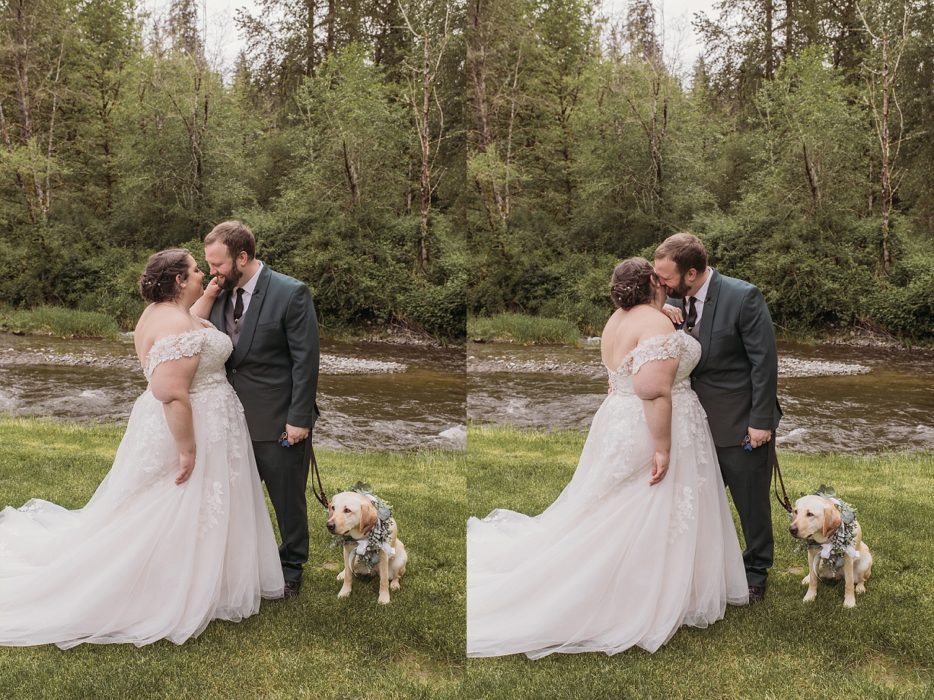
[0,0,468,340]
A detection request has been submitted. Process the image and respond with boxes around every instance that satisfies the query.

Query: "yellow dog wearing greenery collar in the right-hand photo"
[789,492,872,608]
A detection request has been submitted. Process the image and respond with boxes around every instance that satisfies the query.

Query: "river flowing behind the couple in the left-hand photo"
[0,334,466,449]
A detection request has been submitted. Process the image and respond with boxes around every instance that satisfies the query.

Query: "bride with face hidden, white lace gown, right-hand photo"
[467,258,748,658]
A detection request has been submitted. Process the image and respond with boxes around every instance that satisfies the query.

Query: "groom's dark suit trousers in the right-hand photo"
[717,442,775,588]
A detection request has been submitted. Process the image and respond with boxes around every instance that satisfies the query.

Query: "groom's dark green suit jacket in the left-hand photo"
[210,265,320,441]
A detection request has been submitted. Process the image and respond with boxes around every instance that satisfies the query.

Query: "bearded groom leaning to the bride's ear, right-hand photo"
[655,233,782,604]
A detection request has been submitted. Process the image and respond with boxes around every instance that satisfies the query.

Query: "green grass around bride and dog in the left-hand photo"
[0,418,466,699]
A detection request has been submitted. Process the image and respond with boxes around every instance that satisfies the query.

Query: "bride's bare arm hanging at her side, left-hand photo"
[149,355,201,484]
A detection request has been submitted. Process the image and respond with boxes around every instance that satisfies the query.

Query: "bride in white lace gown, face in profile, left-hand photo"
[0,249,283,648]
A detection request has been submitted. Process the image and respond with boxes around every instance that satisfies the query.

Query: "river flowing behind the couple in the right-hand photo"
[467,342,934,452]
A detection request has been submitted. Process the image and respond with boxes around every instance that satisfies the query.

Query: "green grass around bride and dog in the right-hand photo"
[464,426,934,699]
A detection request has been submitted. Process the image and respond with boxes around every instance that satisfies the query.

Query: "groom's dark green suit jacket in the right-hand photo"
[668,268,782,447]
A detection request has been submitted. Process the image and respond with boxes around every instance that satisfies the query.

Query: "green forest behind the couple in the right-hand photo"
[467,0,934,339]
